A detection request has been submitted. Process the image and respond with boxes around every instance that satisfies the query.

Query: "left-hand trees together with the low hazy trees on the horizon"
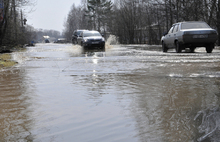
[0,0,62,52]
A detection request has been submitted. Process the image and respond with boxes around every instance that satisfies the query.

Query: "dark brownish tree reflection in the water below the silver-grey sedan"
[112,69,220,142]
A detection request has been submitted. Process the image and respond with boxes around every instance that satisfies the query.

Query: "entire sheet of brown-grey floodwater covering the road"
[0,43,220,142]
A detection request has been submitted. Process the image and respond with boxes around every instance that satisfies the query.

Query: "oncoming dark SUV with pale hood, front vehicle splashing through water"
[78,31,105,50]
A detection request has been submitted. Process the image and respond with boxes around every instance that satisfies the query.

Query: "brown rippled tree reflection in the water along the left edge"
[0,69,34,141]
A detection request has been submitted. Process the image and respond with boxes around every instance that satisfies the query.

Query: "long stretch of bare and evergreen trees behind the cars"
[64,0,220,44]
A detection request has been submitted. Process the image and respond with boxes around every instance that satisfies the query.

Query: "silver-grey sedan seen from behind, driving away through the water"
[161,21,218,53]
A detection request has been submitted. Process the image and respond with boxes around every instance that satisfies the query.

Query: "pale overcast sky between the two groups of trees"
[27,0,81,32]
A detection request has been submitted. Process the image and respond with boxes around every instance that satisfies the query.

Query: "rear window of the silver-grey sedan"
[182,22,210,29]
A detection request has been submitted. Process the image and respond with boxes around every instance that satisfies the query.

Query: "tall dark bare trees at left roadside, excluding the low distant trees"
[0,0,35,51]
